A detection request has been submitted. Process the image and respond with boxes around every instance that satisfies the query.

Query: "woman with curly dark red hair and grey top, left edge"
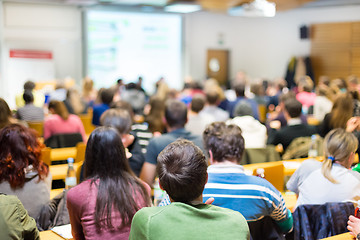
[0,124,52,218]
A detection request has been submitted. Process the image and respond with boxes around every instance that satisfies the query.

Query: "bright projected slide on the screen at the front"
[87,11,183,93]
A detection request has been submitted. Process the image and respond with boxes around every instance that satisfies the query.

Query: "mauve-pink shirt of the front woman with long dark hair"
[67,179,151,240]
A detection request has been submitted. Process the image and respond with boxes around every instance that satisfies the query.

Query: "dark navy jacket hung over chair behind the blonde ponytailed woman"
[293,202,354,240]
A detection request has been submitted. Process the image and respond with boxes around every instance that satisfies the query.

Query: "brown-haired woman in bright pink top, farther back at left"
[44,100,86,142]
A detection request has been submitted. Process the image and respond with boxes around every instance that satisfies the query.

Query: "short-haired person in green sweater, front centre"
[129,139,250,240]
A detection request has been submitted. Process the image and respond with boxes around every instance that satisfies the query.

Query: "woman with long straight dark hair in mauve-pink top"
[67,127,151,240]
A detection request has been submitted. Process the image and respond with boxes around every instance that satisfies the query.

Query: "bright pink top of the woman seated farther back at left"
[44,114,86,142]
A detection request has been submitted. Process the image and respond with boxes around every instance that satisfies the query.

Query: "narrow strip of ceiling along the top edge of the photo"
[3,0,360,12]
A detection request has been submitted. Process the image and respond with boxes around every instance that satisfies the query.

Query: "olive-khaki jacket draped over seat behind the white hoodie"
[241,145,281,164]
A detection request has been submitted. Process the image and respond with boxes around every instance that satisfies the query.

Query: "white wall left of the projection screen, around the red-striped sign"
[0,3,82,107]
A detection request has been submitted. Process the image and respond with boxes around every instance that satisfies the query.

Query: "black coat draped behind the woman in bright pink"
[44,133,83,148]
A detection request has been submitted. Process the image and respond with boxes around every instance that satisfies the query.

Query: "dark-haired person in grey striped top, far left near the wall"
[16,90,44,121]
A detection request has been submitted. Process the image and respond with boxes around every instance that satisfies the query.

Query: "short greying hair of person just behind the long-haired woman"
[100,108,132,134]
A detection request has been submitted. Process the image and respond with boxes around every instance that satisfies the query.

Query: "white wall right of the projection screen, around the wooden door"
[185,6,360,83]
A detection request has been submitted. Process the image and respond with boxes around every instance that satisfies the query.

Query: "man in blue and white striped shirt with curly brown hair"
[203,122,293,239]
